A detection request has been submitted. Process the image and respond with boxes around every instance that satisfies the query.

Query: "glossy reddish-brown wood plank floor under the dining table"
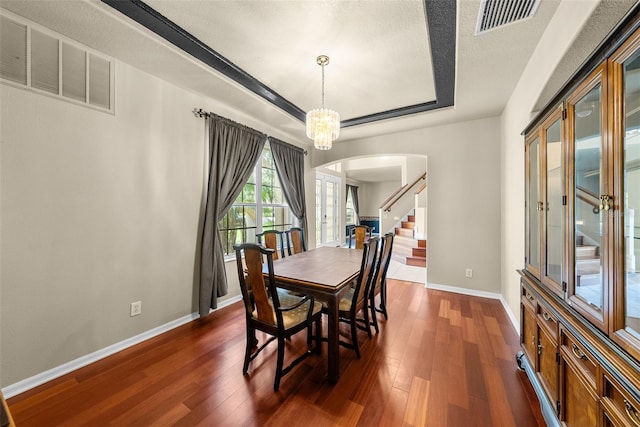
[8,280,544,427]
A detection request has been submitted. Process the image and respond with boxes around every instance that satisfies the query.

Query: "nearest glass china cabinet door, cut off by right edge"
[612,37,640,357]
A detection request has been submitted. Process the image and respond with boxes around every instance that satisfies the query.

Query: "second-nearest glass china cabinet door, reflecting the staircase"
[567,66,612,331]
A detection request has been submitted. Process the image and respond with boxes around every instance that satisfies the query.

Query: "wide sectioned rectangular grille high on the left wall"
[0,16,113,112]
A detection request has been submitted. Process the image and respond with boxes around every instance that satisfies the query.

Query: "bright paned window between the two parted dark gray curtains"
[218,142,292,255]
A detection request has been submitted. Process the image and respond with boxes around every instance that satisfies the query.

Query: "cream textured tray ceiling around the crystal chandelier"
[0,0,558,143]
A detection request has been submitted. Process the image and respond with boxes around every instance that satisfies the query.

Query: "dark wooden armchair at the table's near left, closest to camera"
[233,243,322,391]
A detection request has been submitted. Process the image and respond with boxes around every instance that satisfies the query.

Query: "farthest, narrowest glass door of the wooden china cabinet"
[525,135,542,278]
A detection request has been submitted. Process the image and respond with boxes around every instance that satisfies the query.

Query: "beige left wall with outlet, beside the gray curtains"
[0,58,302,387]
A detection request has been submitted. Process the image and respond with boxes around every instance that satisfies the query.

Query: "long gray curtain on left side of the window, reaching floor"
[200,114,267,317]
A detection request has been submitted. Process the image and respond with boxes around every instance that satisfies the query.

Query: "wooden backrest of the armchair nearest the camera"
[233,243,282,326]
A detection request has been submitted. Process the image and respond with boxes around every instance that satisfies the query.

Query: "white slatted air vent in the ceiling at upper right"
[476,0,540,34]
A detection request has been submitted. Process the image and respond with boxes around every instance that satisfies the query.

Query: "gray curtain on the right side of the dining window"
[269,137,308,243]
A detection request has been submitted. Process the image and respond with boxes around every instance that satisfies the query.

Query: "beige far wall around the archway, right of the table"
[312,118,500,292]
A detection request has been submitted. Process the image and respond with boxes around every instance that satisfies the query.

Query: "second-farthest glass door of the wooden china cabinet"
[541,110,564,296]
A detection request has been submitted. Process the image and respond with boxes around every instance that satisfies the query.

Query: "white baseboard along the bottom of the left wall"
[2,295,242,399]
